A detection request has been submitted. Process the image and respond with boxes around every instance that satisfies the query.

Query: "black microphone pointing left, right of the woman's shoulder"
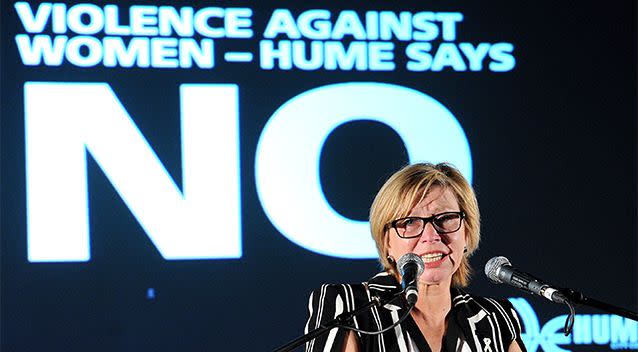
[485,257,567,303]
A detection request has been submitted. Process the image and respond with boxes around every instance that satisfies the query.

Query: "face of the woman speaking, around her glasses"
[386,186,465,286]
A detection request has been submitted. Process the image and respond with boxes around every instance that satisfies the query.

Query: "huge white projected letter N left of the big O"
[24,82,241,262]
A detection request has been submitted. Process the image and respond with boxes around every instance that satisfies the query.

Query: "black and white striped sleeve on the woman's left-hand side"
[304,285,354,352]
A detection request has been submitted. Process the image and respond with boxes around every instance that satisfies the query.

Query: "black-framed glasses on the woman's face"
[390,211,465,238]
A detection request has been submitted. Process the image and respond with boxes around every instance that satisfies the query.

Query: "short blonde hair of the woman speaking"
[370,163,481,287]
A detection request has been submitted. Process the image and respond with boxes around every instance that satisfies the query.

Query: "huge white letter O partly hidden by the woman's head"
[255,82,472,258]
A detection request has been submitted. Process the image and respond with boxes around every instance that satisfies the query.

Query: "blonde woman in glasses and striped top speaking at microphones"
[306,163,525,352]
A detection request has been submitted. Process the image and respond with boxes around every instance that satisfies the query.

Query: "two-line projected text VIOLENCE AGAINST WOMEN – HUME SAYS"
[14,1,516,72]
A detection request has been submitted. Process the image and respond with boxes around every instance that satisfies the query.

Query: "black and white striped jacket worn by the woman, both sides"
[305,272,525,352]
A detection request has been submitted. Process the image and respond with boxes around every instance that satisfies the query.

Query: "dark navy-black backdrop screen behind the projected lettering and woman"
[1,1,638,351]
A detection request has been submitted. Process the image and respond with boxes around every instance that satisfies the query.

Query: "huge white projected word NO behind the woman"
[25,82,472,262]
